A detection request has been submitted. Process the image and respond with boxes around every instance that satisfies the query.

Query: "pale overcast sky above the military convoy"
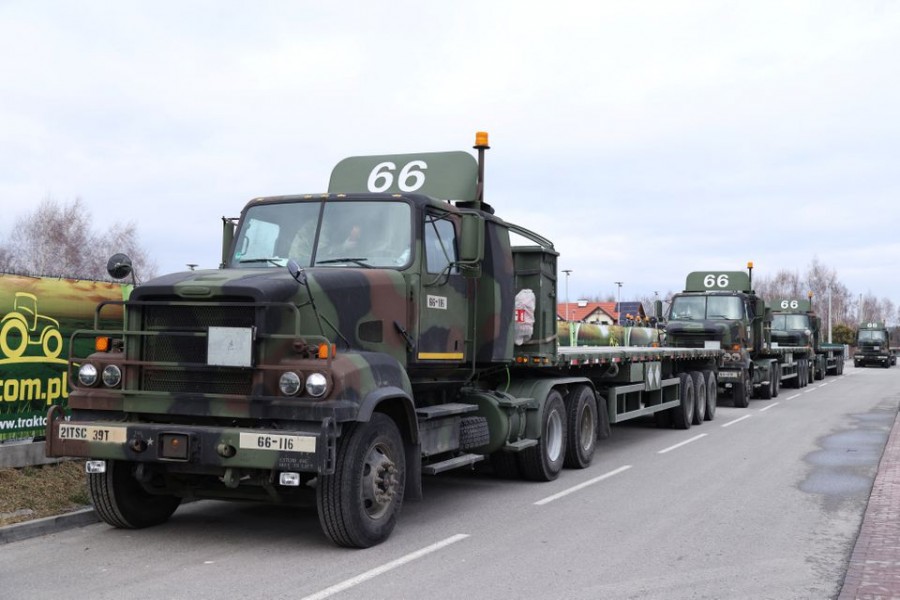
[0,0,900,304]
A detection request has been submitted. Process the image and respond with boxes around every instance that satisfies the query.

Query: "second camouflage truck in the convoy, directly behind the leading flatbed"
[666,263,813,408]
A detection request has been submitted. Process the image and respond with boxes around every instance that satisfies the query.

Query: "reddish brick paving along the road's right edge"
[838,414,900,600]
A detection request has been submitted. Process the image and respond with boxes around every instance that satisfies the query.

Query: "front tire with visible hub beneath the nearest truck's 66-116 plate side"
[316,413,406,548]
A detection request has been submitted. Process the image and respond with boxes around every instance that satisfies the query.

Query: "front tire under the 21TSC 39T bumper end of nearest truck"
[87,460,181,529]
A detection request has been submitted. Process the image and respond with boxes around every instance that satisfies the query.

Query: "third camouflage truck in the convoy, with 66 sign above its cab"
[770,295,844,383]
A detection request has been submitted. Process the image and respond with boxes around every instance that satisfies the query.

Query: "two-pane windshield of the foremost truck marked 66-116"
[229,200,412,268]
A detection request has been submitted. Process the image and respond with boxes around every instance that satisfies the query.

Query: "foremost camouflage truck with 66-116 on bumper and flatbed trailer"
[47,134,721,547]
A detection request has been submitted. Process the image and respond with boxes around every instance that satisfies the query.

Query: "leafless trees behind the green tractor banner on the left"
[0,198,156,279]
